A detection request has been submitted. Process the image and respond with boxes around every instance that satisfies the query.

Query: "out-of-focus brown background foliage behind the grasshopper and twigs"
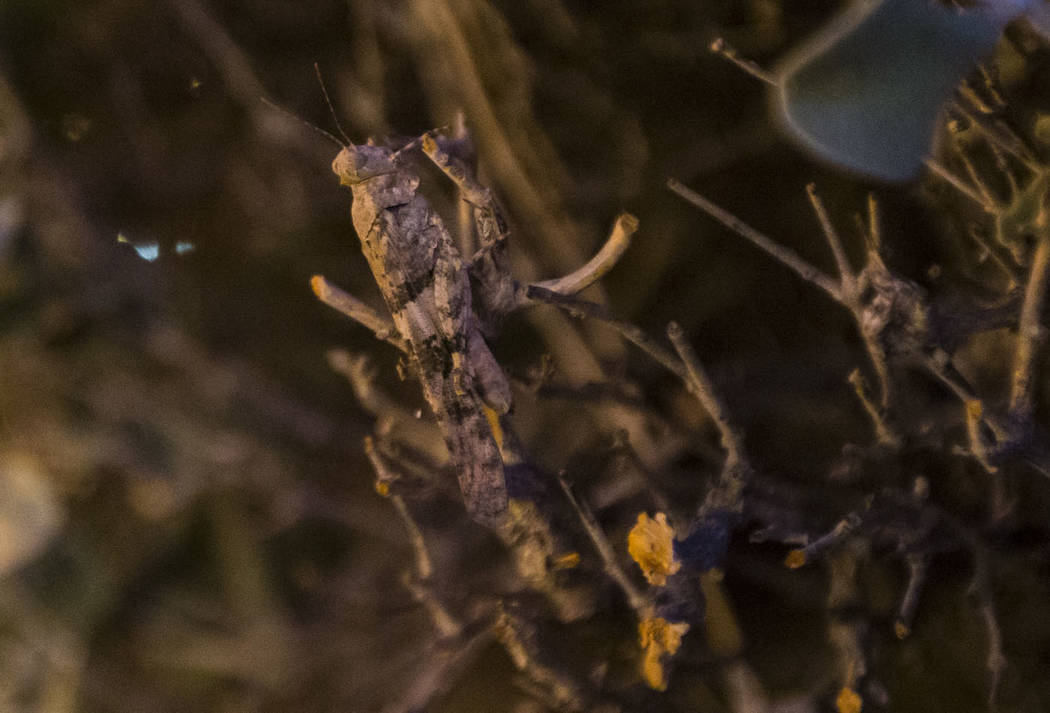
[0,0,1050,713]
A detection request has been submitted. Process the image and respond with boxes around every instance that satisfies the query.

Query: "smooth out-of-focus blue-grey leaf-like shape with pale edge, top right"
[777,0,1012,181]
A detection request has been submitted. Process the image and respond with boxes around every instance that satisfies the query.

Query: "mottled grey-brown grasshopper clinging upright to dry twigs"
[332,134,512,526]
